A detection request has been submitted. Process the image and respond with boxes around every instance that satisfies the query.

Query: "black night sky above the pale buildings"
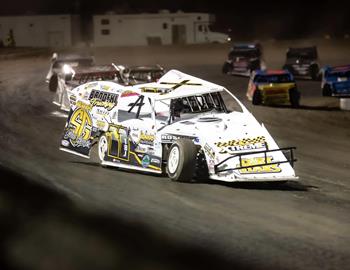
[0,0,350,38]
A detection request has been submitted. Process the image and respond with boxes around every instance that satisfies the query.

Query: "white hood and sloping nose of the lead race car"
[161,112,295,181]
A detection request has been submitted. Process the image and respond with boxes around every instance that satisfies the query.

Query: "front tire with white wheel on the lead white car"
[166,138,198,182]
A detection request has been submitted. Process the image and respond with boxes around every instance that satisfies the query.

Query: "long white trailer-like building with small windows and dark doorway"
[93,12,229,46]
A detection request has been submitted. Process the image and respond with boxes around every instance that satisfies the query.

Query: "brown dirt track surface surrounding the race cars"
[0,41,350,270]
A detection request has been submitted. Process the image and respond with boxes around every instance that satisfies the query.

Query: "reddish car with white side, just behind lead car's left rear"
[53,63,125,111]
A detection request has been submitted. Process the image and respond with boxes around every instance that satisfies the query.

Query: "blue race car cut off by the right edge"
[321,65,350,97]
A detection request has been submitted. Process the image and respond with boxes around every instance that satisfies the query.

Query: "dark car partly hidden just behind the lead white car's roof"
[123,65,165,85]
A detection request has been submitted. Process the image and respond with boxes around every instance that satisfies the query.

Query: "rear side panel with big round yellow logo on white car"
[60,107,96,158]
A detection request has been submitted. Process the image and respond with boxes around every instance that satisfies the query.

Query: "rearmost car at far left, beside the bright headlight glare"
[46,53,95,92]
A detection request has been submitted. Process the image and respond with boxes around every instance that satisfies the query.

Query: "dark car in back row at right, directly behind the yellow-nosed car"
[222,43,266,76]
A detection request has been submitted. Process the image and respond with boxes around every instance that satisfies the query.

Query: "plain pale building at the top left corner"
[0,15,81,47]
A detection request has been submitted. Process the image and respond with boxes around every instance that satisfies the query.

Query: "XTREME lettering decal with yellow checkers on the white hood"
[215,136,266,155]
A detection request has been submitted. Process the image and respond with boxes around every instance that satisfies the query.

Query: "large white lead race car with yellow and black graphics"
[60,70,297,182]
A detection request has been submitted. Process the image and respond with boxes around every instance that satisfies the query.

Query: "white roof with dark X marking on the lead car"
[134,69,225,100]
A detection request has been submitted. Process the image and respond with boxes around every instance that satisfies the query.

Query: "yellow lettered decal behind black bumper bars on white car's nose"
[238,157,282,174]
